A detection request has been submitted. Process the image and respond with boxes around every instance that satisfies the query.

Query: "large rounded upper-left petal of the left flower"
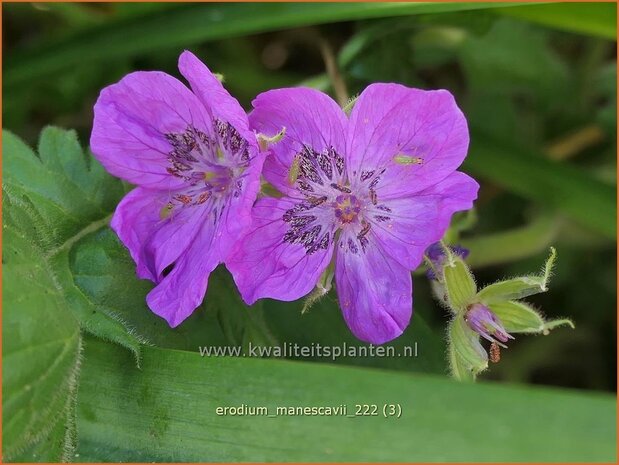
[90,71,211,190]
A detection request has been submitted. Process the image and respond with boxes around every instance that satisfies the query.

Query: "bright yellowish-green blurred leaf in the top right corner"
[496,2,617,39]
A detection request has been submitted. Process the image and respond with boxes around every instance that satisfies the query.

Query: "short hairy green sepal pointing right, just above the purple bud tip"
[489,301,574,334]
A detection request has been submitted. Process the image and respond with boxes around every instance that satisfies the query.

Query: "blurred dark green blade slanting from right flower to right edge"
[462,129,617,240]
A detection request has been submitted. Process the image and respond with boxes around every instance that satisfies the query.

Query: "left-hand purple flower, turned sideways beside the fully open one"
[90,52,264,327]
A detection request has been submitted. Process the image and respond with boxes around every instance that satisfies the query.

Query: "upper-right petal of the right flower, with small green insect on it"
[347,84,469,198]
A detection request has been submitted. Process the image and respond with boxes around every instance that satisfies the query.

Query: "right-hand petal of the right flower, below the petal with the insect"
[371,171,479,270]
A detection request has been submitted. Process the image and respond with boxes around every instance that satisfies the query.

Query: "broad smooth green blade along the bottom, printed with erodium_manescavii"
[76,340,616,462]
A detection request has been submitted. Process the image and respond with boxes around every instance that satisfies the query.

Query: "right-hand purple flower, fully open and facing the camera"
[228,84,479,344]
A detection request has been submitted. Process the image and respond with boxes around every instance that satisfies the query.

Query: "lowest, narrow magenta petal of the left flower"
[146,221,220,328]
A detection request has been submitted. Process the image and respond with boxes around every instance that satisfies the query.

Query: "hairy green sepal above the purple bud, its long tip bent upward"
[477,247,557,305]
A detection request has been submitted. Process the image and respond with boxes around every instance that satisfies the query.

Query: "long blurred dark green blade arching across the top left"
[4,2,518,86]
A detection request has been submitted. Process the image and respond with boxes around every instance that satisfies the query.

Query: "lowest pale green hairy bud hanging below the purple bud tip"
[447,315,488,381]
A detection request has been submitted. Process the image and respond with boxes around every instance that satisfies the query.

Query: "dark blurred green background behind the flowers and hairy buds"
[3,3,617,391]
